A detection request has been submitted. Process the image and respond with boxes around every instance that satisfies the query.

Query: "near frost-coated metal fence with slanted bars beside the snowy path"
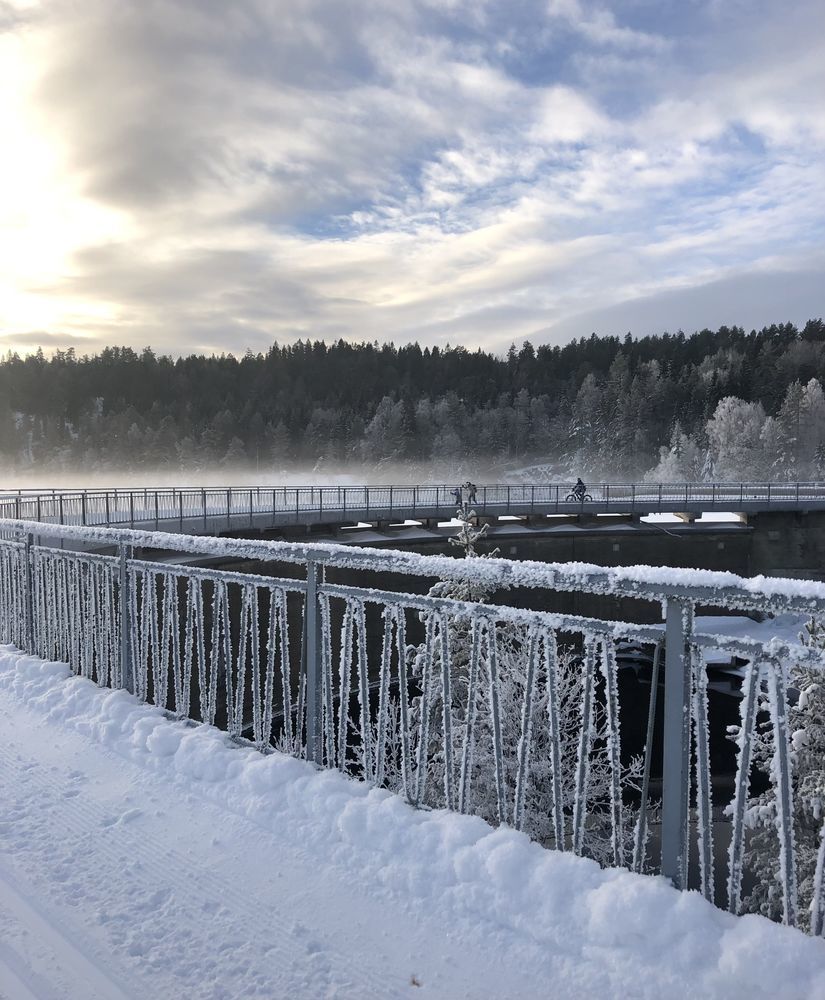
[0,520,825,927]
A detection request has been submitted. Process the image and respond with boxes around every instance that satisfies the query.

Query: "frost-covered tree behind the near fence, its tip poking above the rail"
[391,508,641,863]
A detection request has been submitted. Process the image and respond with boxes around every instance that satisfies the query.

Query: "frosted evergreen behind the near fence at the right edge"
[731,619,825,933]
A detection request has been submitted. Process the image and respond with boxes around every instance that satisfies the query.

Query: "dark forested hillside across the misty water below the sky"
[0,320,825,479]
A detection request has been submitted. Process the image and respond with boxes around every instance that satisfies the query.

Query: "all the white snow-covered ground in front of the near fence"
[0,647,825,1000]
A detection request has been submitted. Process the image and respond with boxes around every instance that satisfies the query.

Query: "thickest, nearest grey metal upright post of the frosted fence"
[662,599,693,889]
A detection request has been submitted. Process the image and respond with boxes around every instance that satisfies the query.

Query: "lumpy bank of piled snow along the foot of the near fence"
[0,646,825,998]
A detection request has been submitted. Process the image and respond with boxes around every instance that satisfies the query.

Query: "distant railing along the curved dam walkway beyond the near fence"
[0,482,825,533]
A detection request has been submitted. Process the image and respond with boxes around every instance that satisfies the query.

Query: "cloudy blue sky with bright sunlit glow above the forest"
[0,0,825,355]
